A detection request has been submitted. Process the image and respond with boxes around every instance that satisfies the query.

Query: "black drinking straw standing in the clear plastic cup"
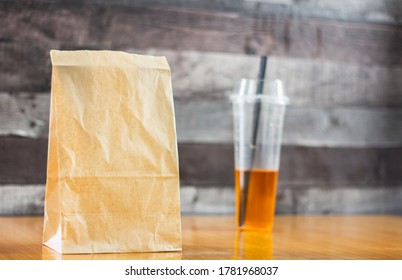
[239,56,268,227]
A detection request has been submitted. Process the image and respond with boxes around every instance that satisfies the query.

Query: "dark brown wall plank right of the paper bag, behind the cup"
[179,143,402,188]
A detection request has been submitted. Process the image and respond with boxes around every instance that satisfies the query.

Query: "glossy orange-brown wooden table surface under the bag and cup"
[0,216,402,260]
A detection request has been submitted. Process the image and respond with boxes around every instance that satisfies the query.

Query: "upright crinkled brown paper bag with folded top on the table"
[43,51,181,253]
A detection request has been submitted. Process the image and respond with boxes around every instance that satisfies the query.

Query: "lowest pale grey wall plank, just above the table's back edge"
[0,185,402,215]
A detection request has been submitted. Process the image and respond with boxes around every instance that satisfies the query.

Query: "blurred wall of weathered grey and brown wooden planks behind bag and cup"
[0,0,402,215]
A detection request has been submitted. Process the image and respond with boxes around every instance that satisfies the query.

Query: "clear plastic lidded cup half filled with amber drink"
[231,79,288,231]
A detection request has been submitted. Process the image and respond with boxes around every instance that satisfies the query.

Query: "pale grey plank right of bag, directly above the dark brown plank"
[175,101,402,148]
